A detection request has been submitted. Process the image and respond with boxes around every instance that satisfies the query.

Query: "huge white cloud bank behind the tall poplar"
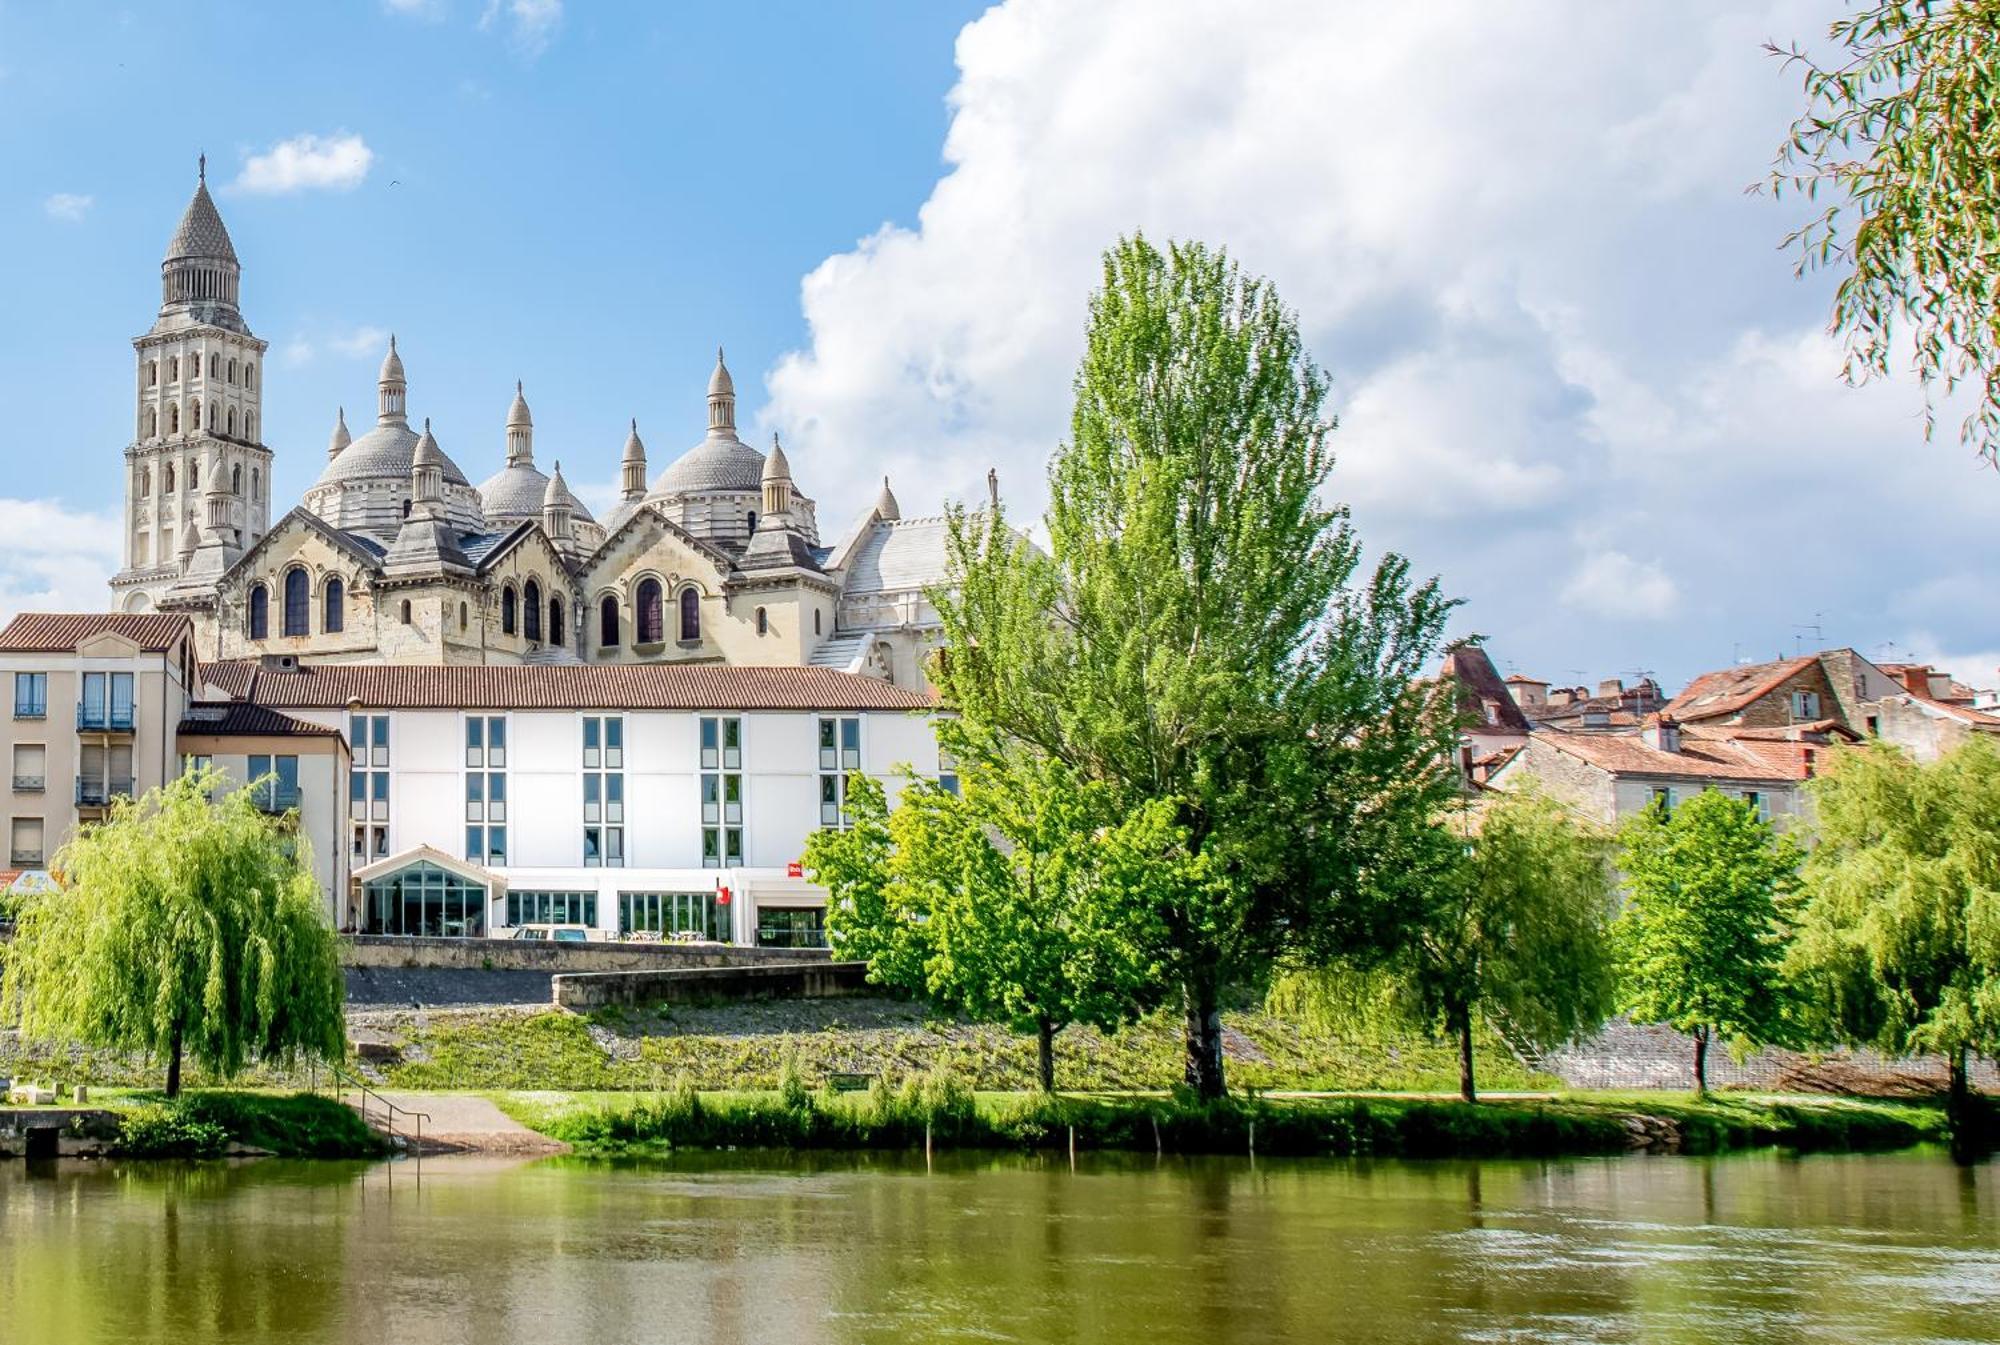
[762,0,2000,681]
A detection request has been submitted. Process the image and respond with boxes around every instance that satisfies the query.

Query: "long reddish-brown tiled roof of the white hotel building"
[204,658,932,711]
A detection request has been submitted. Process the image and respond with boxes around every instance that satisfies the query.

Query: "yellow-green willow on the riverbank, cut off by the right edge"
[1790,739,2000,1135]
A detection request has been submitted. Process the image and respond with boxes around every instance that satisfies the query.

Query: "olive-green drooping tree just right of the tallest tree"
[1272,791,1616,1103]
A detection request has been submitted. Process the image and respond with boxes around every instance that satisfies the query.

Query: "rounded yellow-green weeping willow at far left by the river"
[6,771,346,1097]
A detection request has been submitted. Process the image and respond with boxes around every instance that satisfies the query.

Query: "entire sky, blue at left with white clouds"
[0,0,2000,691]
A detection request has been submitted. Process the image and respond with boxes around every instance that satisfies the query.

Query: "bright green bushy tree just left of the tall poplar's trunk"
[806,723,1178,1091]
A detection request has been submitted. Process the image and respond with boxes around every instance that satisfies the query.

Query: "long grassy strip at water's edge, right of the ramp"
[496,1075,1944,1157]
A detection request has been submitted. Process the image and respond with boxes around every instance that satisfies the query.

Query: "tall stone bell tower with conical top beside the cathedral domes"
[112,156,272,612]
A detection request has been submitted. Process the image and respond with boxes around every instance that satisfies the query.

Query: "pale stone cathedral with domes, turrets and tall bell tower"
[112,172,964,689]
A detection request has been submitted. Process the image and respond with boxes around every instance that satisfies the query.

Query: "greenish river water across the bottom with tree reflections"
[0,1155,2000,1345]
